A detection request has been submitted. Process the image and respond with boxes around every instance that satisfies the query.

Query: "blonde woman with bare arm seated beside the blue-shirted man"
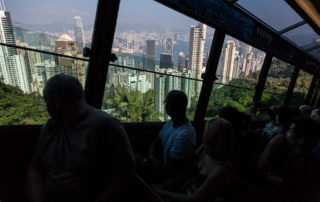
[155,118,233,202]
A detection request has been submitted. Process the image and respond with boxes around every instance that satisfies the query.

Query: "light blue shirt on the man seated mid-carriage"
[158,120,197,164]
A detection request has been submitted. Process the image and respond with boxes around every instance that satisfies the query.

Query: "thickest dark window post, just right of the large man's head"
[85,0,120,108]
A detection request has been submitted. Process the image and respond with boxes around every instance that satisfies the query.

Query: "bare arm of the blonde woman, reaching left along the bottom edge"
[156,166,232,202]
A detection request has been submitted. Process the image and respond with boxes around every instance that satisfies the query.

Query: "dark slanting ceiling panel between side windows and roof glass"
[155,0,320,74]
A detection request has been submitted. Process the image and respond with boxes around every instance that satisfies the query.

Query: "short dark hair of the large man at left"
[43,74,84,103]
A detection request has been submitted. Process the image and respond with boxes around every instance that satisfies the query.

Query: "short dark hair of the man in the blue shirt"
[165,90,188,114]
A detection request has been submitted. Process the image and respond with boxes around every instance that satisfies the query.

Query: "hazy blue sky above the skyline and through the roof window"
[4,0,318,35]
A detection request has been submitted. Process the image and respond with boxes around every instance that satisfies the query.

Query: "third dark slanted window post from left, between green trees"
[253,53,273,103]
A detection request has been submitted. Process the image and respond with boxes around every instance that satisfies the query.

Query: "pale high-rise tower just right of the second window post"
[217,40,236,83]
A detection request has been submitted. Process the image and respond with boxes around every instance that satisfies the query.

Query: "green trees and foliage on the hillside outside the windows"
[0,60,312,125]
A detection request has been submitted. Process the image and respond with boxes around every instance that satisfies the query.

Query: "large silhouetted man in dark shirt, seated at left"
[27,74,135,202]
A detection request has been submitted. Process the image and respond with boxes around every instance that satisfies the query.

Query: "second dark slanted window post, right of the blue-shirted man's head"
[194,30,225,123]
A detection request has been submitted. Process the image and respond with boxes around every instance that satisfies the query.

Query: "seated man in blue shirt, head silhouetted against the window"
[147,90,196,182]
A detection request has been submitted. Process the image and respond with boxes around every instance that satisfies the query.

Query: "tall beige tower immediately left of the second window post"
[188,23,207,93]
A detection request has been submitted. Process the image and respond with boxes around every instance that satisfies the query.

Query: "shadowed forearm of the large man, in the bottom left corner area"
[27,166,46,202]
